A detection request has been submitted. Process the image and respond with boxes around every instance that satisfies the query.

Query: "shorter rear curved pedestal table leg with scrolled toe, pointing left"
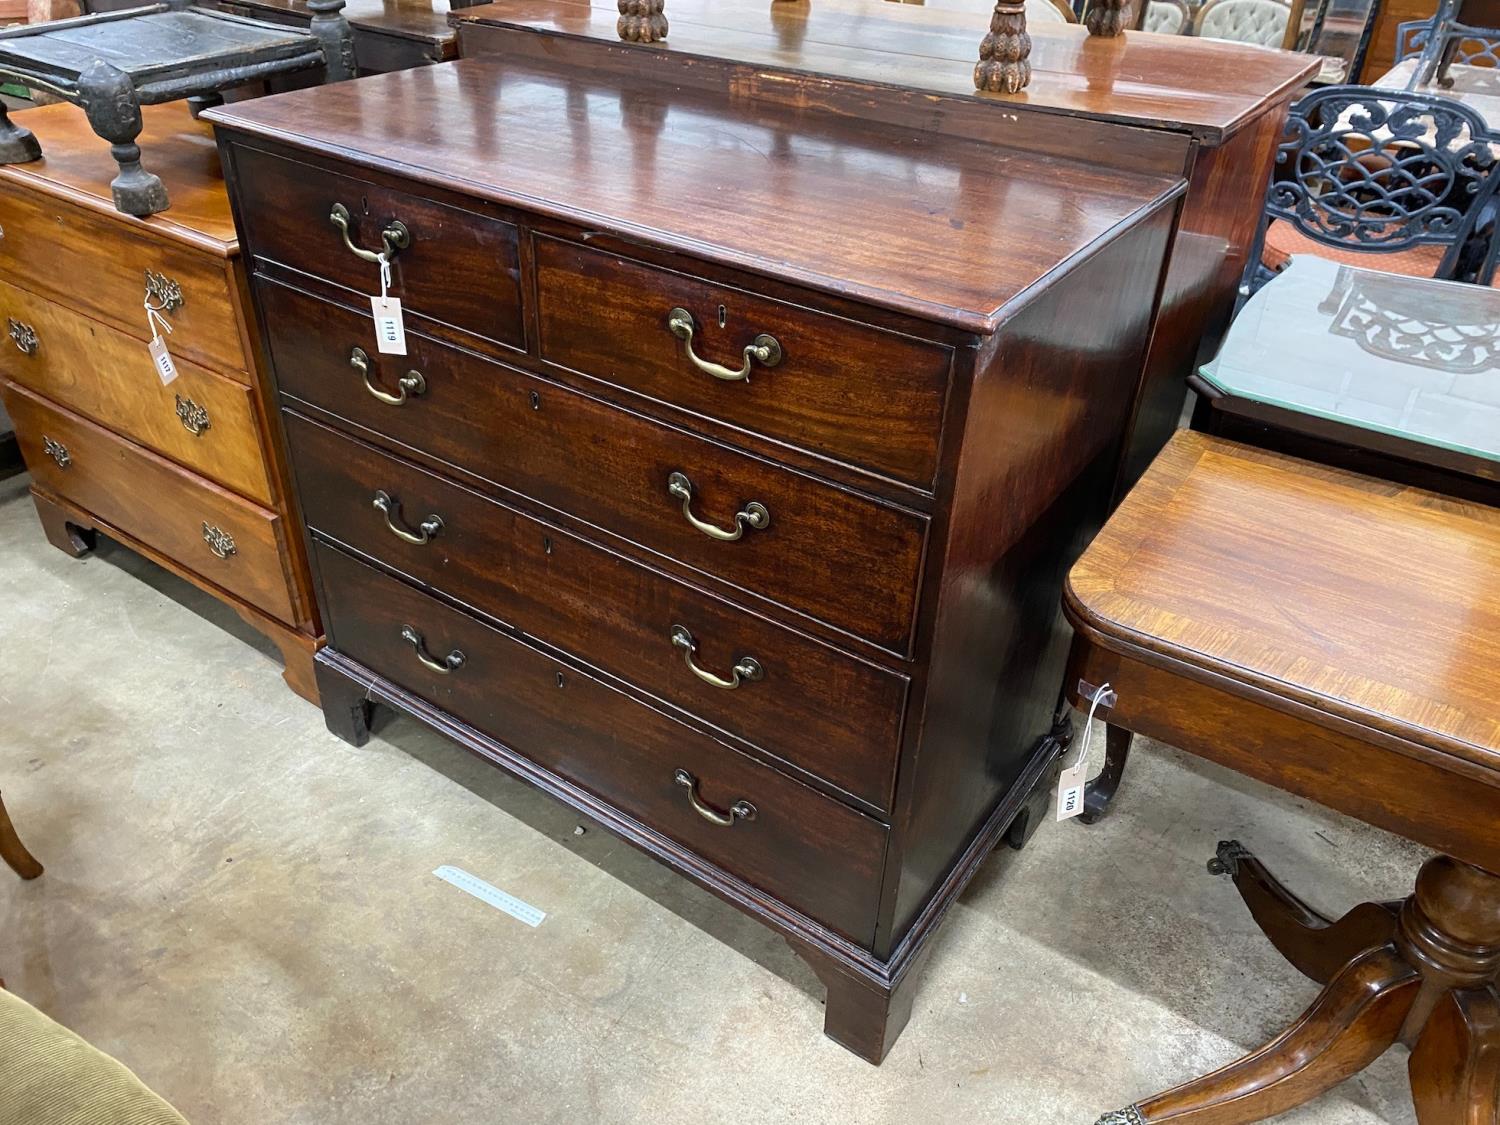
[1209,840,1401,984]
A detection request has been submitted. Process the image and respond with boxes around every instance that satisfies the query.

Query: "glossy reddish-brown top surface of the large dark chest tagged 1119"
[206,59,1182,333]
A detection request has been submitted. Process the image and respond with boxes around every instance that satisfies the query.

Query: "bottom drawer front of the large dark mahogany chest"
[315,545,887,945]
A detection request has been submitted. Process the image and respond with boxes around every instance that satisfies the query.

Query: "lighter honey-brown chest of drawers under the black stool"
[0,102,321,702]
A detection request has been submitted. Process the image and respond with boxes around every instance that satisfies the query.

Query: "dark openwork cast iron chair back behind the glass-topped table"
[1242,86,1500,297]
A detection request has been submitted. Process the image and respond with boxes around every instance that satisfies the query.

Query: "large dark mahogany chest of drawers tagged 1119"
[207,50,1182,1061]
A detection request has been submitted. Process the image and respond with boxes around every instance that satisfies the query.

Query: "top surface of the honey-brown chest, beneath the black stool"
[0,102,239,257]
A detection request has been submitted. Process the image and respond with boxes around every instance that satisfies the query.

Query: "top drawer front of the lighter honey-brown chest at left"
[0,183,254,381]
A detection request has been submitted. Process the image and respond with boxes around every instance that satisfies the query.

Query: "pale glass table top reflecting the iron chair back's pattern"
[1202,255,1500,462]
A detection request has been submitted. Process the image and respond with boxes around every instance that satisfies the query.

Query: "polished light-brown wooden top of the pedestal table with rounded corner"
[1065,432,1500,788]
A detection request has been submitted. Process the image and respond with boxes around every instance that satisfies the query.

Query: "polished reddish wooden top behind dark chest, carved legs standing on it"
[452,0,1319,143]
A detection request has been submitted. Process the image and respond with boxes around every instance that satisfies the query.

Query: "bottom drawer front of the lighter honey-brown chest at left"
[5,383,303,626]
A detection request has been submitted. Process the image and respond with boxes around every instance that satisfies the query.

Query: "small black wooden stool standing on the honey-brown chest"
[0,0,354,218]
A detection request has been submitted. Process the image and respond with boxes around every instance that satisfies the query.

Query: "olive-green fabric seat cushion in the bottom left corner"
[0,989,188,1125]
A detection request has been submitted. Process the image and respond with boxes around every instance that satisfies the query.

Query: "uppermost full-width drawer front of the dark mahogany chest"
[268,279,927,653]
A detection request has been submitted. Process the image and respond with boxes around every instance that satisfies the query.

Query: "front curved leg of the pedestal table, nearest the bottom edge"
[1098,947,1425,1125]
